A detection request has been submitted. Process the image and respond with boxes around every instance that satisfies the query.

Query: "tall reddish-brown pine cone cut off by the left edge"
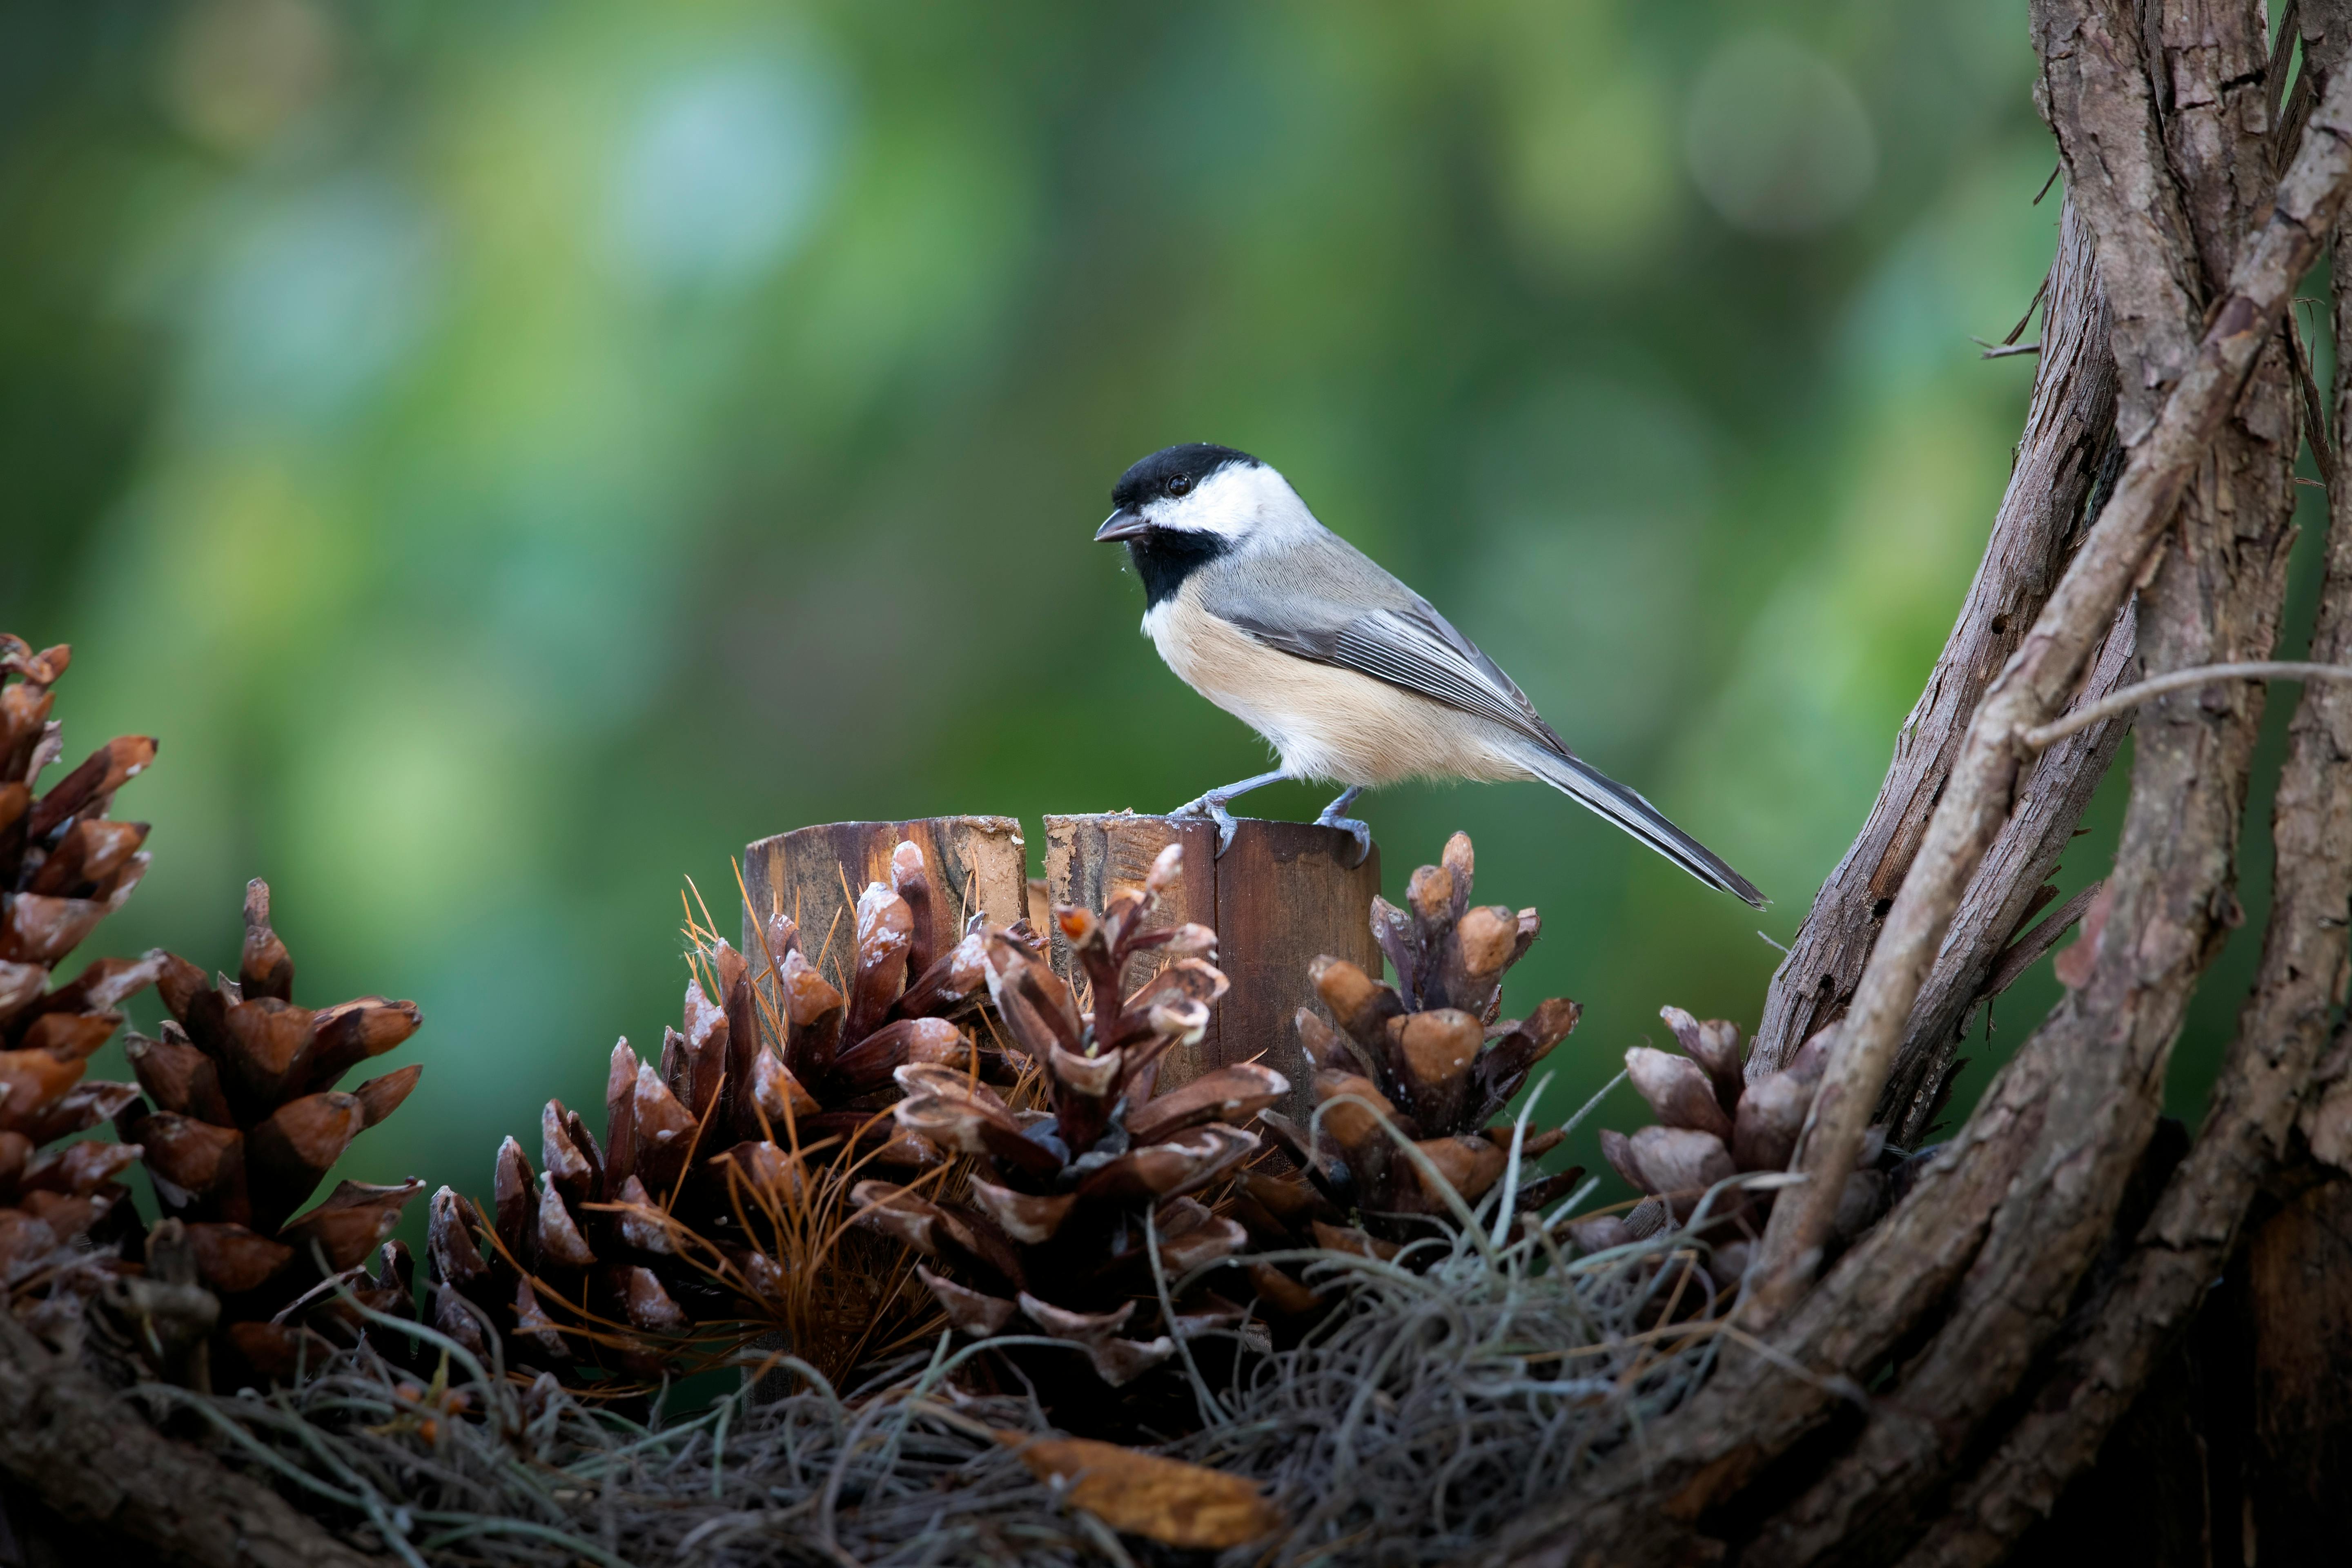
[0,635,165,1338]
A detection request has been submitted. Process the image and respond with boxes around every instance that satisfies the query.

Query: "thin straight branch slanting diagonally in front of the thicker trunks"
[1752,18,2352,1323]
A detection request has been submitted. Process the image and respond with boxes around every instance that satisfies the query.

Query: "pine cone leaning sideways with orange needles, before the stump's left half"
[428,844,1007,1375]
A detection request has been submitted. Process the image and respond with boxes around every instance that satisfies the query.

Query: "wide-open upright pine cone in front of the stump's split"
[851,844,1289,1387]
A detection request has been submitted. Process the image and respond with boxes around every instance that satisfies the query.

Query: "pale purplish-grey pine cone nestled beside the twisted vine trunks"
[1569,1006,1891,1288]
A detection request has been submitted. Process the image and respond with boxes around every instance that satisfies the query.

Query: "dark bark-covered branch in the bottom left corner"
[0,1312,388,1568]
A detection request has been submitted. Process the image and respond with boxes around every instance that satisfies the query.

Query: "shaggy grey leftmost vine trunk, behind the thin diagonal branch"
[1748,200,2129,1091]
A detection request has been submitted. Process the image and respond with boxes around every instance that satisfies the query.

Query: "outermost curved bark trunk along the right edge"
[1903,147,2352,1568]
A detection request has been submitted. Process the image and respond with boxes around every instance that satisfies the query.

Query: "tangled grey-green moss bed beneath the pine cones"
[143,1166,1768,1568]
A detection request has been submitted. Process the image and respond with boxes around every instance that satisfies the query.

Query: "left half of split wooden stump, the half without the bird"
[743,816,1028,978]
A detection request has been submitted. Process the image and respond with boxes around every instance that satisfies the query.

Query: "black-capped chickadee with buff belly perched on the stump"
[1094,442,1764,907]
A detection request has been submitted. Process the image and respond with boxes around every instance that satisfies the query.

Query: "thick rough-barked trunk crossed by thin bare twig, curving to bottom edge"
[1745,5,2298,1566]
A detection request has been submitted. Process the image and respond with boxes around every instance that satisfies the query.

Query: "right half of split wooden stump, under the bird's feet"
[1044,811,1381,1121]
